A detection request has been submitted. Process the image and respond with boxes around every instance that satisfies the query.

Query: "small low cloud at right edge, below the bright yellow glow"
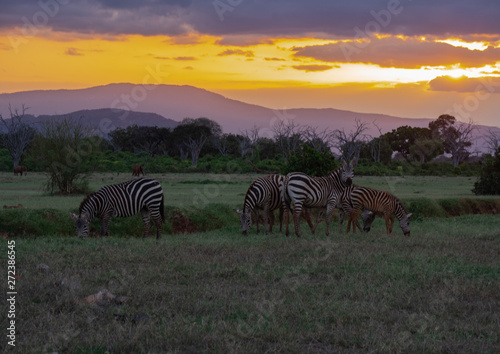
[429,76,500,93]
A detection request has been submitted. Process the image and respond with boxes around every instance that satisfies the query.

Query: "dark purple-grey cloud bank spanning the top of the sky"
[0,0,500,38]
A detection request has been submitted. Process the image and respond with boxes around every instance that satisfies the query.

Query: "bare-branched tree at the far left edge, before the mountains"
[0,105,35,166]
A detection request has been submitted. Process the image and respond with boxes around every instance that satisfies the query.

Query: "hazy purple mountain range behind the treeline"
[0,84,500,150]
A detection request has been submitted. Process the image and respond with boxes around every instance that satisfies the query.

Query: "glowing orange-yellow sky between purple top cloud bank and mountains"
[0,0,500,126]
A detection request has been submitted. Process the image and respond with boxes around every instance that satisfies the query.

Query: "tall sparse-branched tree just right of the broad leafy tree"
[429,114,474,167]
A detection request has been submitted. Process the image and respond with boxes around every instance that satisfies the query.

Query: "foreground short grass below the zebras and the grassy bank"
[0,215,500,353]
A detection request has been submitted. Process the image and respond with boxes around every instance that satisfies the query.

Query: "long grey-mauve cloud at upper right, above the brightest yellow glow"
[294,37,500,68]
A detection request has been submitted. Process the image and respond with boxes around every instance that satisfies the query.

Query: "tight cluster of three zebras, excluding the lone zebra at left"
[236,161,412,236]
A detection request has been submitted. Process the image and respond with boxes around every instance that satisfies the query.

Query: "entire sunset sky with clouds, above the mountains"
[0,0,500,126]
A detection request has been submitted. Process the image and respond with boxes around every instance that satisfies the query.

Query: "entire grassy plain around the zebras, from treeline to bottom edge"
[0,173,500,353]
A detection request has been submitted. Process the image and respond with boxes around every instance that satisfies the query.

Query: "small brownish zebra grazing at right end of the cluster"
[342,187,412,236]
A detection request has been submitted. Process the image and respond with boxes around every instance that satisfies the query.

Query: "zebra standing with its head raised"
[283,159,354,236]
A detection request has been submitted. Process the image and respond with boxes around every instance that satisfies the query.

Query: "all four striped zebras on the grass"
[70,160,412,239]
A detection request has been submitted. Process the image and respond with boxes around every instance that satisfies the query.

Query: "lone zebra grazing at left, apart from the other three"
[70,178,165,239]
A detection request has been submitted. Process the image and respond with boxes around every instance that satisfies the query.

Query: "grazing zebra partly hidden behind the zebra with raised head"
[235,175,284,235]
